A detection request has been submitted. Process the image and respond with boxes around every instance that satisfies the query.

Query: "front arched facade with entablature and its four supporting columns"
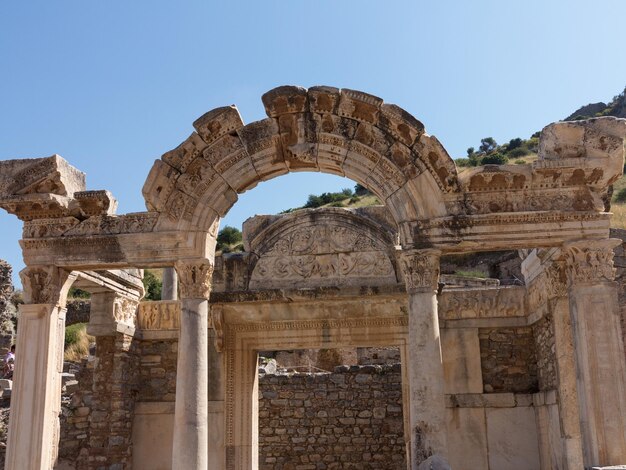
[0,87,626,470]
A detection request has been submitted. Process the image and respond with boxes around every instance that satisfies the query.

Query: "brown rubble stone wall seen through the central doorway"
[259,364,406,470]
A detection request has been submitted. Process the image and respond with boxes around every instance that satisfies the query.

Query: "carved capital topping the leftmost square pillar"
[20,266,71,306]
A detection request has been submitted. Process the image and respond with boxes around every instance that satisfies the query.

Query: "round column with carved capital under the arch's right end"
[400,249,449,470]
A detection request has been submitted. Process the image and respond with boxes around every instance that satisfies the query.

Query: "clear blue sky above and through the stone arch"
[0,0,626,284]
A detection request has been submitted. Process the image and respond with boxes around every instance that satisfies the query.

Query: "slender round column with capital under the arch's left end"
[172,260,213,470]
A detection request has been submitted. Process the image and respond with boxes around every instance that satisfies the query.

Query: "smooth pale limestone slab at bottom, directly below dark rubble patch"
[481,407,540,470]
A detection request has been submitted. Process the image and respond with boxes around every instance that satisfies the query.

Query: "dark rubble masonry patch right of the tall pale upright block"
[478,327,538,393]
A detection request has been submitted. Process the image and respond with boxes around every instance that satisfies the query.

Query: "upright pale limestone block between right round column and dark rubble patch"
[441,328,483,394]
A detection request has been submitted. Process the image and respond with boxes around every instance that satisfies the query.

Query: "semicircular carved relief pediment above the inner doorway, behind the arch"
[244,208,398,290]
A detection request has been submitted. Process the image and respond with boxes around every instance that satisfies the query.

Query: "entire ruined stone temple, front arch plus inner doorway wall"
[0,87,626,470]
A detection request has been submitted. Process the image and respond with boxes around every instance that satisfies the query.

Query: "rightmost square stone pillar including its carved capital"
[563,239,626,467]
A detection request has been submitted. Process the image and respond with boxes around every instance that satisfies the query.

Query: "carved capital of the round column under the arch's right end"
[400,249,441,294]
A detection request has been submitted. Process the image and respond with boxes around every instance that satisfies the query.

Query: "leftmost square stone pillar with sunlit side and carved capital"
[5,266,73,470]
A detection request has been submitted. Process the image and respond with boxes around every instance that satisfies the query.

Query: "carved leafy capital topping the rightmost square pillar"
[563,238,622,285]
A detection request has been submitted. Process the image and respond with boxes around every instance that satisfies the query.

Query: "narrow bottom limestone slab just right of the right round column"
[446,408,489,470]
